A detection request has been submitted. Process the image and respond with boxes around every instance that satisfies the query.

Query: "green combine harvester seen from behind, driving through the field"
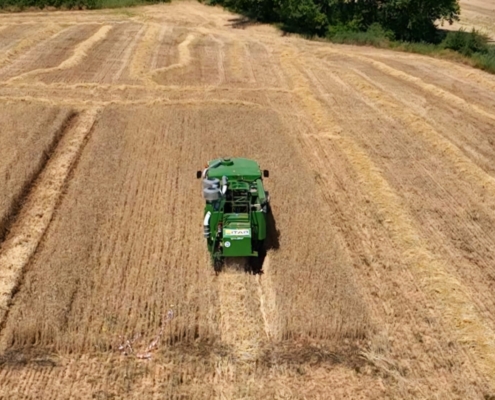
[197,158,270,273]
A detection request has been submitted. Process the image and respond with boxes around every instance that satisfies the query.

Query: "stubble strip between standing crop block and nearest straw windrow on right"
[272,50,495,396]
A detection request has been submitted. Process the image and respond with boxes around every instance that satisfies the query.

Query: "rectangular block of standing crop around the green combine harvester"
[3,107,376,400]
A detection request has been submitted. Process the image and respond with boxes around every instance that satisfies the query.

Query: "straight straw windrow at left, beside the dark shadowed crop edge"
[0,108,99,327]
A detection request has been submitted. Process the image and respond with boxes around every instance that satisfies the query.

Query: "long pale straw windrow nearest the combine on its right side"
[281,45,495,389]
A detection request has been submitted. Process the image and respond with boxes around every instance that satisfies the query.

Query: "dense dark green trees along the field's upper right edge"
[207,0,460,42]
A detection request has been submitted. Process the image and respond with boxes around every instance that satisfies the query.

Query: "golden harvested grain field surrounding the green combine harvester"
[0,1,495,399]
